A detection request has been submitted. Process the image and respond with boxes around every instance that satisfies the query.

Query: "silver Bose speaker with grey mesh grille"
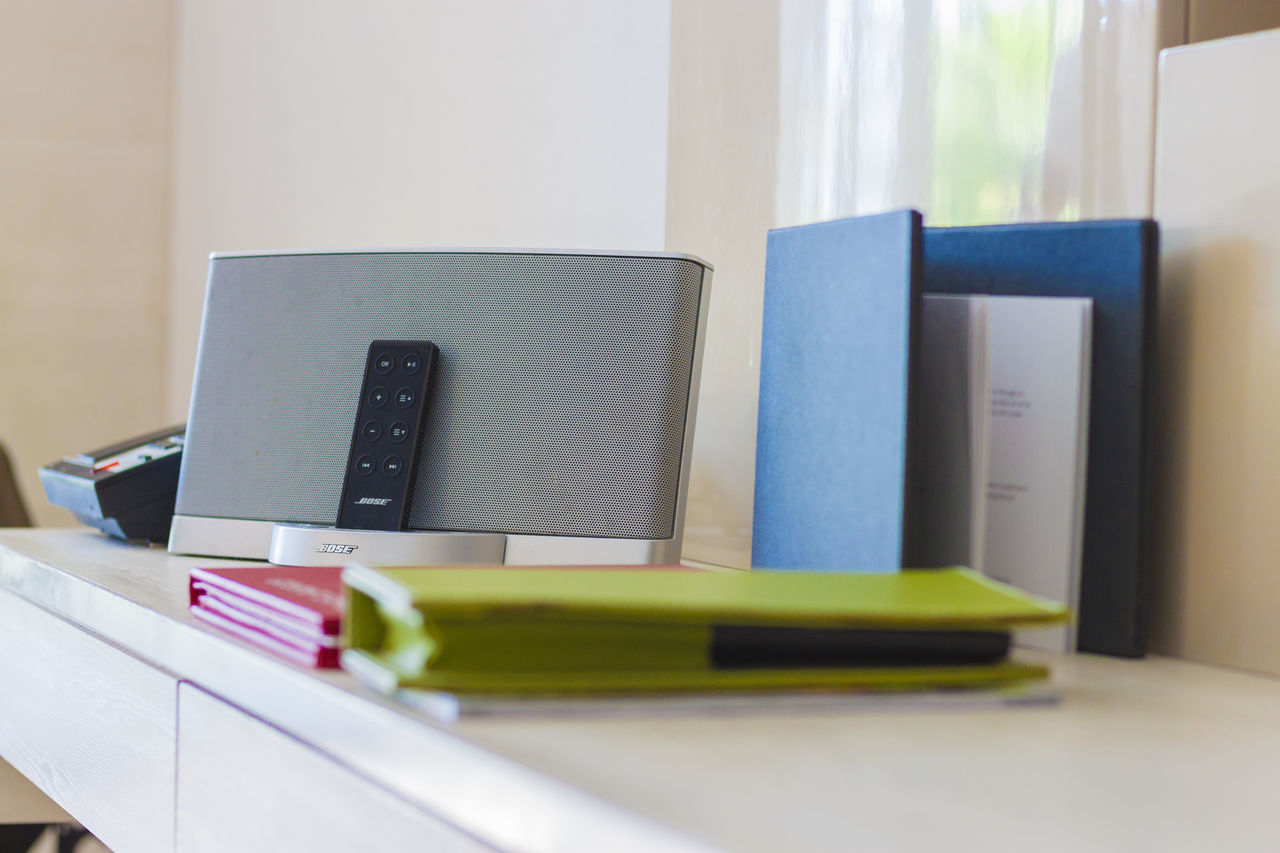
[169,250,712,564]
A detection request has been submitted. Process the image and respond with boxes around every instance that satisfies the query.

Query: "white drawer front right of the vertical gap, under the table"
[177,684,493,853]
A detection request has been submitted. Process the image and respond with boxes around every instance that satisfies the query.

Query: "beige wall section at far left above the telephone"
[0,0,172,524]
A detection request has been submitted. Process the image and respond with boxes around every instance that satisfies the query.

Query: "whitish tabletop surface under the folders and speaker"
[0,530,1280,852]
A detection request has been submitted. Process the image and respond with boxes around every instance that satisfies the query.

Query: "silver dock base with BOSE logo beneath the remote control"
[268,524,507,566]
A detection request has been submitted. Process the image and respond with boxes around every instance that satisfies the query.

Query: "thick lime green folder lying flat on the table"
[342,565,1068,694]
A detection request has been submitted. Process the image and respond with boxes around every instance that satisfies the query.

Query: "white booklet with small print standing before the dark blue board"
[916,295,1093,652]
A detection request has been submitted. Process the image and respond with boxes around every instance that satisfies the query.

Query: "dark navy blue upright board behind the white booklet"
[923,219,1160,657]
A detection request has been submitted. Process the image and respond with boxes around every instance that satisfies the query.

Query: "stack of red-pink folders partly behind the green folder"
[191,566,344,667]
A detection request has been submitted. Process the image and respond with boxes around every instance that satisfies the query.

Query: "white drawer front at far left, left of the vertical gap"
[0,590,178,853]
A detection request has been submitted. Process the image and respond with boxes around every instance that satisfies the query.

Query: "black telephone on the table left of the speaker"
[40,424,187,542]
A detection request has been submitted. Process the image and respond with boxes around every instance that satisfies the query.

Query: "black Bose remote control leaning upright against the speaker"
[338,341,439,530]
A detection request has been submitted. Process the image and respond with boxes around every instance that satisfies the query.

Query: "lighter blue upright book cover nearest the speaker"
[751,210,922,571]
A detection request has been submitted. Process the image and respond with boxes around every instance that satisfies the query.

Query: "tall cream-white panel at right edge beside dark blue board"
[1152,31,1280,675]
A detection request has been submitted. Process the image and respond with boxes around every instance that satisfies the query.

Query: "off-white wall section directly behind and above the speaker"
[166,0,669,419]
